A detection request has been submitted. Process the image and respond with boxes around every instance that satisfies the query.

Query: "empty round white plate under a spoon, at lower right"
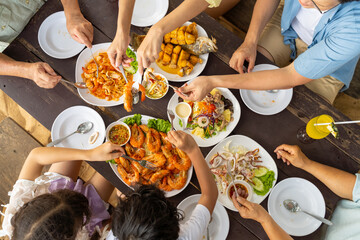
[268,178,325,236]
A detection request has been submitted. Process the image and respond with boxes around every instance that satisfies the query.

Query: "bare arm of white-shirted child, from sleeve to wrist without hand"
[188,148,218,212]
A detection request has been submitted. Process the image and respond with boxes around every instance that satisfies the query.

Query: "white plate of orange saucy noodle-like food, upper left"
[75,43,141,107]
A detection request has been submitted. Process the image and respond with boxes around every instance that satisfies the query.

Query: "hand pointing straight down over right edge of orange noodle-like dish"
[107,31,130,71]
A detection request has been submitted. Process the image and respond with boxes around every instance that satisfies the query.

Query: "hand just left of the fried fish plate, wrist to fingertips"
[137,27,164,74]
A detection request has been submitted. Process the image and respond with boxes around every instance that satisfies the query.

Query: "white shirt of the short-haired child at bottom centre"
[106,204,211,240]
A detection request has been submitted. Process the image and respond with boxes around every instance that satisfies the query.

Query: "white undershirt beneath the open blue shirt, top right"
[291,6,322,45]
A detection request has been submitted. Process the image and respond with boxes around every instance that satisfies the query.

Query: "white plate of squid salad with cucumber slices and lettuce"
[205,135,278,211]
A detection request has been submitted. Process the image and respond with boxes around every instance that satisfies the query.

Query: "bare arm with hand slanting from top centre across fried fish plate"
[137,0,209,74]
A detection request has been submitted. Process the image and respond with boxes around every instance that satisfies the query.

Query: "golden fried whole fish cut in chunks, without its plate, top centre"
[131,22,217,77]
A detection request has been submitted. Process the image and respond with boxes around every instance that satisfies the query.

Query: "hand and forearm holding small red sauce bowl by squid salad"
[232,194,292,240]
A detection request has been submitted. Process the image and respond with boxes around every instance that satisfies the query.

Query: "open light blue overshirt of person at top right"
[281,0,360,90]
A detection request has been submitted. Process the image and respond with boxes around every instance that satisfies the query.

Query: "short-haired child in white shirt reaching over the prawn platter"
[106,131,218,240]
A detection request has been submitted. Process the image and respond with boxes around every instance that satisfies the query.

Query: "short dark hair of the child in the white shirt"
[112,185,183,240]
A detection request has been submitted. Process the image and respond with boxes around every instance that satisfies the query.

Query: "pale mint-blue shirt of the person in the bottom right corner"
[325,174,360,240]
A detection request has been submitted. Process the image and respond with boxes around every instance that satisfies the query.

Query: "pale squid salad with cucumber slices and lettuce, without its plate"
[209,141,275,196]
